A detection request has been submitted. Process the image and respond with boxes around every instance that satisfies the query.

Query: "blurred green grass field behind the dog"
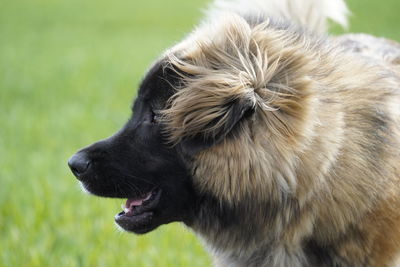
[0,0,400,267]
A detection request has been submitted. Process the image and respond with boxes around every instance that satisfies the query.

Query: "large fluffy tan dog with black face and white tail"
[68,0,400,266]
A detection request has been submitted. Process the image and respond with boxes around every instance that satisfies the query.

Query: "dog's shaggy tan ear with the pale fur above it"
[164,16,263,155]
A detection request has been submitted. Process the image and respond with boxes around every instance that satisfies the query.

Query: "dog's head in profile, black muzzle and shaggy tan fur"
[69,16,318,237]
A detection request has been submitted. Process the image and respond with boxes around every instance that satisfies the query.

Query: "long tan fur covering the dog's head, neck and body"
[163,15,400,266]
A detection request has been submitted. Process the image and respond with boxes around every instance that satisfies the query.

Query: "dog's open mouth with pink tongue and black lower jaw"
[115,189,161,233]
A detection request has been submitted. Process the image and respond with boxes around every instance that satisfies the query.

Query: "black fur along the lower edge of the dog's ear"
[180,96,255,156]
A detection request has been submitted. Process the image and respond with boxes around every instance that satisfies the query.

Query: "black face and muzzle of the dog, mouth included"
[68,64,195,233]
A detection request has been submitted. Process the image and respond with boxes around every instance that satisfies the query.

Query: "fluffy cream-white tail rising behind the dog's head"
[208,0,349,33]
